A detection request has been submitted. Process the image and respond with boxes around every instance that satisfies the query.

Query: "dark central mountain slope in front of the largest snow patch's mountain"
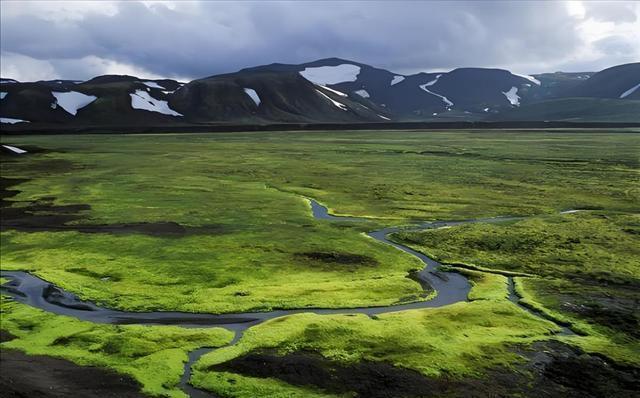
[170,69,384,122]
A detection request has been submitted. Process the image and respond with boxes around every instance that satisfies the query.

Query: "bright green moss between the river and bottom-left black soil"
[0,298,233,397]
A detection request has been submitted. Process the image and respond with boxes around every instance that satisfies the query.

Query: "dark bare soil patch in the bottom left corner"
[0,349,144,398]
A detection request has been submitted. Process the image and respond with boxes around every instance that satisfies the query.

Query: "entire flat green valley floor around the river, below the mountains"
[0,130,640,397]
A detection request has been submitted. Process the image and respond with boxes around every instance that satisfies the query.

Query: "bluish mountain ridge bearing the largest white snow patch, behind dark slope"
[243,58,535,116]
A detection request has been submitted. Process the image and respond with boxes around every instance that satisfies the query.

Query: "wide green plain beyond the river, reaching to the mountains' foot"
[1,132,640,312]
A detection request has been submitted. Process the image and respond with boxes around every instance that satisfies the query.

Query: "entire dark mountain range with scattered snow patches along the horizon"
[0,58,640,129]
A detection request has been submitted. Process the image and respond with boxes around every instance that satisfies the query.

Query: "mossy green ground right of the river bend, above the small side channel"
[394,211,640,362]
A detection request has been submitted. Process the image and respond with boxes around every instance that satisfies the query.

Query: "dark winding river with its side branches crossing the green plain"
[0,199,576,398]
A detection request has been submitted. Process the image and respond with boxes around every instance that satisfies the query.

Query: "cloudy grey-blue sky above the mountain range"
[0,0,640,81]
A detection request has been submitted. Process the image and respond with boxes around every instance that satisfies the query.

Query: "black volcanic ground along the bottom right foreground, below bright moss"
[210,341,640,398]
